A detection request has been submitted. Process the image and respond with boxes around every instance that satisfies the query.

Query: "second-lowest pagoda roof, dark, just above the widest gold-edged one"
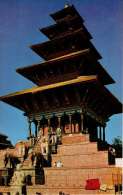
[16,49,114,86]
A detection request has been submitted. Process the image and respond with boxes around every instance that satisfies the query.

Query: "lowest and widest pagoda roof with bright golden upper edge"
[0,75,122,119]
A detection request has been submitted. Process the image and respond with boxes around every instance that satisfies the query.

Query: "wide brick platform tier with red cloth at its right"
[44,166,117,188]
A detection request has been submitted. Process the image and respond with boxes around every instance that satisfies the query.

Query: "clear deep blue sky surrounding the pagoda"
[0,0,123,144]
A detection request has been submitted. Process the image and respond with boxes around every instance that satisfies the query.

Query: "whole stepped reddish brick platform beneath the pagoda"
[27,134,116,195]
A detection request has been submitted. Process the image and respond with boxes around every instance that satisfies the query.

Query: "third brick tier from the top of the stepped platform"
[52,151,108,168]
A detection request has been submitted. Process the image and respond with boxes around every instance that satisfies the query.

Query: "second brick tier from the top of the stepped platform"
[57,142,97,155]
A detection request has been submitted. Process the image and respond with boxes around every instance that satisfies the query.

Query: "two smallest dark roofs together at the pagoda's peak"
[40,6,92,39]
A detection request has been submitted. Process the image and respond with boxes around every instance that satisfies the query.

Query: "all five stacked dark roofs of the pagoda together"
[0,5,122,124]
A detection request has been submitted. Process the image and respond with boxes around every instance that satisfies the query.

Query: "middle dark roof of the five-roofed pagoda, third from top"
[30,28,101,60]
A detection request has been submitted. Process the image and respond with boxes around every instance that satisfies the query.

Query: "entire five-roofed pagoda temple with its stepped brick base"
[0,5,122,195]
